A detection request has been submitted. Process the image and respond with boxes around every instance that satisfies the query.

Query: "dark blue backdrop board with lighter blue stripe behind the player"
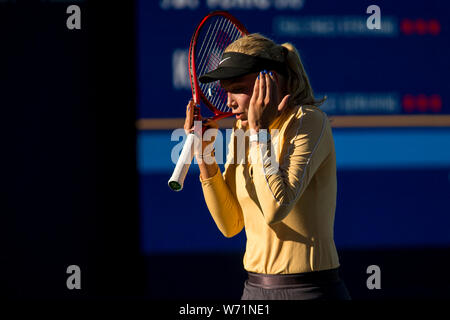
[137,0,450,253]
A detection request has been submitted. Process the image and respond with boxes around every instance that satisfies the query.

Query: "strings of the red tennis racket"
[195,16,242,112]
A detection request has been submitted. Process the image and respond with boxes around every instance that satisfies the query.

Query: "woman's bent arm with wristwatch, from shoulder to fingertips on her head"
[248,72,332,224]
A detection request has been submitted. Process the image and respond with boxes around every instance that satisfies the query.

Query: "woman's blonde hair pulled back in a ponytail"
[225,33,326,105]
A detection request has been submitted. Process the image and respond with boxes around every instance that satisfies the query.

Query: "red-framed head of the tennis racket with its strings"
[188,11,248,120]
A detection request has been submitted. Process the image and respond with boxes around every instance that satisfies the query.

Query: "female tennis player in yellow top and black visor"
[185,34,350,300]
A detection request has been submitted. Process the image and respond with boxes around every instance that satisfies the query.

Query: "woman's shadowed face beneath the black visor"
[220,73,258,127]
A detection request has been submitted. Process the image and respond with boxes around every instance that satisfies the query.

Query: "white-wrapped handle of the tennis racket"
[168,133,195,191]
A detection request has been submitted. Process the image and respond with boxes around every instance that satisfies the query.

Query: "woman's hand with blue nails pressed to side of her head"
[247,72,290,132]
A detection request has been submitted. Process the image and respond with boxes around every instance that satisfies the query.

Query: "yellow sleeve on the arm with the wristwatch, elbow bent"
[250,108,330,224]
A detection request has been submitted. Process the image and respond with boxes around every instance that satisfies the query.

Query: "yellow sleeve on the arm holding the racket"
[200,128,244,238]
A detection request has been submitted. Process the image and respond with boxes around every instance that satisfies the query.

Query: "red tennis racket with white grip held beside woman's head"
[168,11,248,191]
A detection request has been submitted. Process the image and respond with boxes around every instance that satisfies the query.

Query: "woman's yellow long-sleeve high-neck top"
[200,106,339,274]
